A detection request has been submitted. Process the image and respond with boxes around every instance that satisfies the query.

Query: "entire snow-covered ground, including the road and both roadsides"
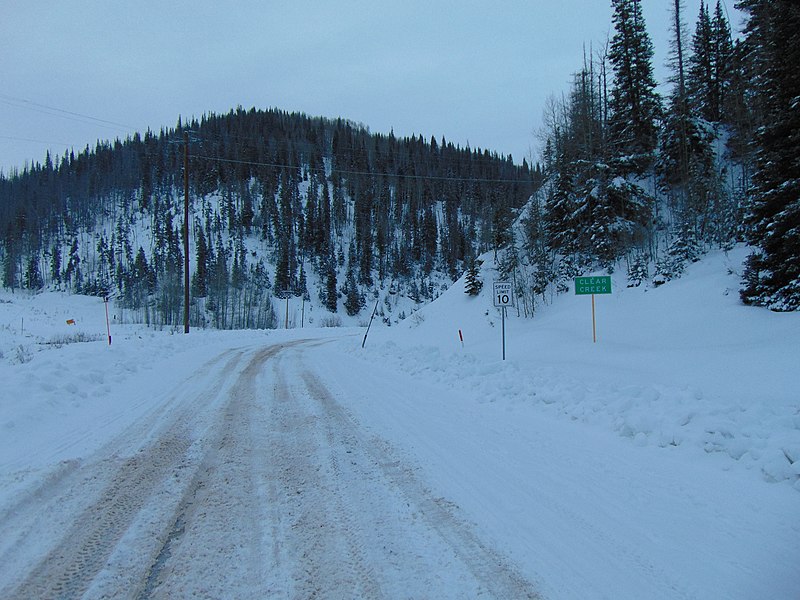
[0,249,800,600]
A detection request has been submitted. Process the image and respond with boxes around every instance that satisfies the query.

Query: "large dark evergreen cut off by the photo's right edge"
[741,0,800,310]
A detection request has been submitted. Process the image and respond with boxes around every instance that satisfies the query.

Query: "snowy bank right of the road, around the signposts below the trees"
[354,249,800,491]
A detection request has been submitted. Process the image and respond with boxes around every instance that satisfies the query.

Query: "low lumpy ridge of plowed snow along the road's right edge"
[362,342,800,491]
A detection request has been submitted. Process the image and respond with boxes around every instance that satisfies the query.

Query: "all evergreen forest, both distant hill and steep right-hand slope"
[0,0,800,328]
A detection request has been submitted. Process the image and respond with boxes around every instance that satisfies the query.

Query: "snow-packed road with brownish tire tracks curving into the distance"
[0,342,537,598]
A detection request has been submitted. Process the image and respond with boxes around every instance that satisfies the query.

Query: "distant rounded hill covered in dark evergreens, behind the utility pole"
[0,109,541,328]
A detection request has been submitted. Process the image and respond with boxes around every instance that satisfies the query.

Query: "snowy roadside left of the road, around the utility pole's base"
[0,291,296,476]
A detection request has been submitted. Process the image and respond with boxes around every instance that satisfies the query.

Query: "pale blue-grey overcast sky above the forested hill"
[0,0,741,175]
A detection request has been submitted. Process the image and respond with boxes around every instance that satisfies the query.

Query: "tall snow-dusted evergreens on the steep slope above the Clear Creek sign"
[501,0,800,312]
